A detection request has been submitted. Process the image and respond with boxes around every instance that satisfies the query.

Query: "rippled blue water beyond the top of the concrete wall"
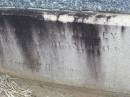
[0,0,130,13]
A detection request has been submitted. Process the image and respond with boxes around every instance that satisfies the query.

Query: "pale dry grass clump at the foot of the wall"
[0,75,32,97]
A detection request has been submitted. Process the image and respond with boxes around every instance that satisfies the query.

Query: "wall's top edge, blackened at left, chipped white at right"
[0,8,130,26]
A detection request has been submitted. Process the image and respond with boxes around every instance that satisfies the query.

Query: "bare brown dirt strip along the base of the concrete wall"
[0,73,130,97]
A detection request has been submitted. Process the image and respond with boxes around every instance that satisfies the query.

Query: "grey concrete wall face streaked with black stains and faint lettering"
[0,11,130,92]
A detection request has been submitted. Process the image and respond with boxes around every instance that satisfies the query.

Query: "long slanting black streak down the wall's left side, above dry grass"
[5,15,40,71]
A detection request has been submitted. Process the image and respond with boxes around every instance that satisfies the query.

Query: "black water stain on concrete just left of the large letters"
[72,23,101,80]
